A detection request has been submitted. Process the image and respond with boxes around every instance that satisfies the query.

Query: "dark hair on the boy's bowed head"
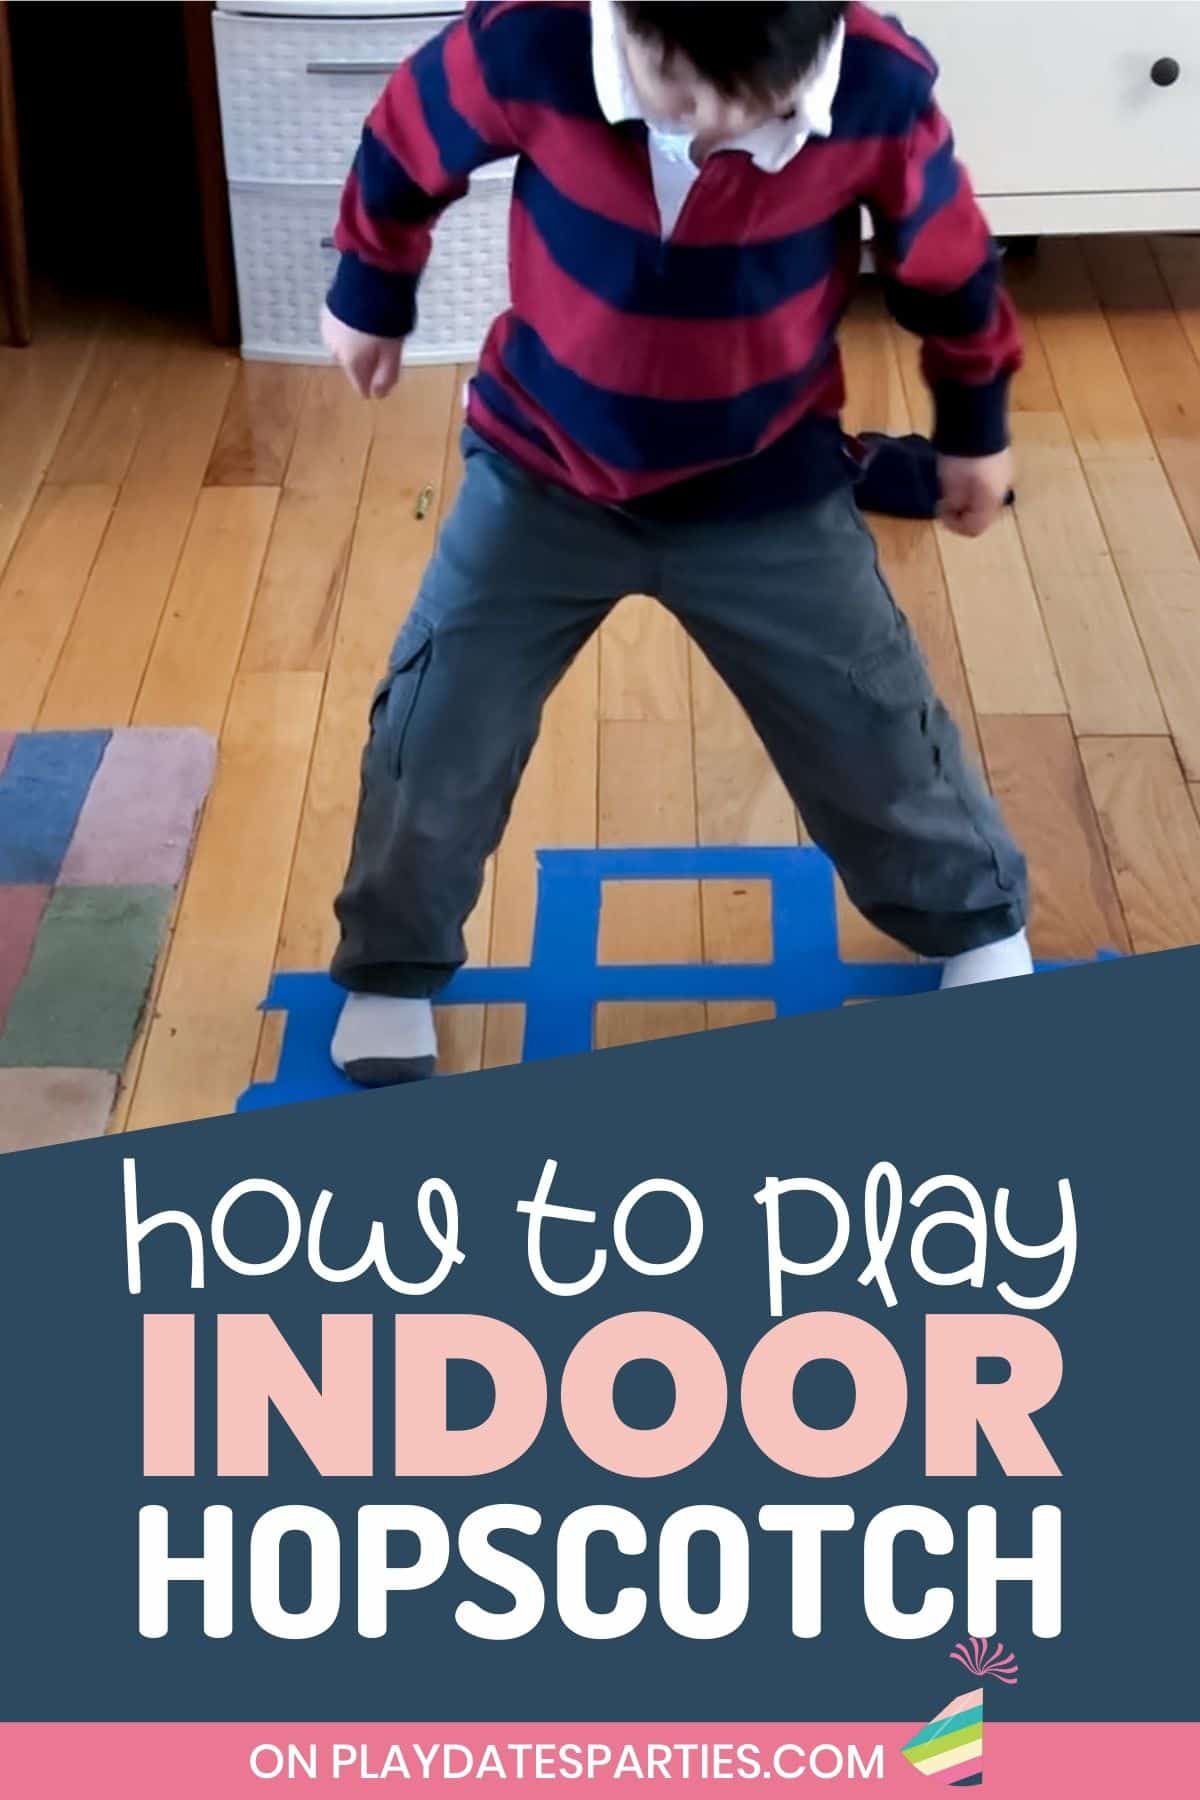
[621,0,846,99]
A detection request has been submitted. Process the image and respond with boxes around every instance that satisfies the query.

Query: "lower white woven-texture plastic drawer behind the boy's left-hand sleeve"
[230,180,511,362]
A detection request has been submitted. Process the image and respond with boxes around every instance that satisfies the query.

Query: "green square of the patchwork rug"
[0,887,173,1075]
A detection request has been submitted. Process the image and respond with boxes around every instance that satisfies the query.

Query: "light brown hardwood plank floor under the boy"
[0,239,1200,1129]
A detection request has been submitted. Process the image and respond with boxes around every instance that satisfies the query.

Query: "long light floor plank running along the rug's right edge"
[128,669,320,1130]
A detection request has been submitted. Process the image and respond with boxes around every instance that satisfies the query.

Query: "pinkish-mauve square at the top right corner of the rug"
[59,729,216,887]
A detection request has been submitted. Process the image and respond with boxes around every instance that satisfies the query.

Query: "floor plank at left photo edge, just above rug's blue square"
[0,486,117,731]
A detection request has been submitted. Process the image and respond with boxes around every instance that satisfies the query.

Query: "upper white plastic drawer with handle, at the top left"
[212,7,453,182]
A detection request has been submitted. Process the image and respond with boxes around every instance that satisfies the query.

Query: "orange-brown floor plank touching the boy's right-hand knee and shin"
[979,716,1130,959]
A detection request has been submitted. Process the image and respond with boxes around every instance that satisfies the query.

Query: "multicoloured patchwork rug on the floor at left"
[0,729,216,1150]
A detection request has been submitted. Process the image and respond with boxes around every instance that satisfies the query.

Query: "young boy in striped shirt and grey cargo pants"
[324,0,1033,1085]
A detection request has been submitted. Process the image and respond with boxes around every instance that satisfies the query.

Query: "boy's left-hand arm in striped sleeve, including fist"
[322,5,518,398]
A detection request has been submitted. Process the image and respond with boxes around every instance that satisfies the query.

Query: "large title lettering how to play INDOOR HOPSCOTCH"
[124,1157,1078,1642]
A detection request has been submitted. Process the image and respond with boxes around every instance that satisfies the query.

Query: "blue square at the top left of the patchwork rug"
[0,731,110,886]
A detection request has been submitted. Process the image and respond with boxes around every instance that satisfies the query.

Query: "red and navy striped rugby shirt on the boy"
[329,0,1020,509]
